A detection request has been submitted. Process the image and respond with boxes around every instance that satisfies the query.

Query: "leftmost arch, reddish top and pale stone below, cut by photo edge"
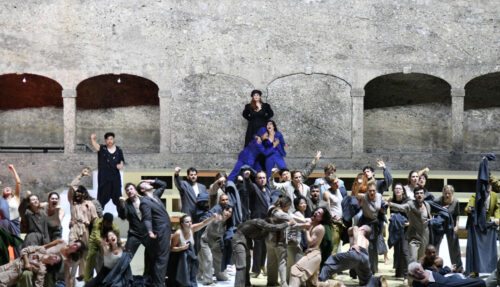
[0,74,64,152]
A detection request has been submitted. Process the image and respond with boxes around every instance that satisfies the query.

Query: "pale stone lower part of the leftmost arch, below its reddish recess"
[0,108,64,147]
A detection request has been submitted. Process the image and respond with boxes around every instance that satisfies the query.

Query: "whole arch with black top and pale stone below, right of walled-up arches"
[363,73,452,152]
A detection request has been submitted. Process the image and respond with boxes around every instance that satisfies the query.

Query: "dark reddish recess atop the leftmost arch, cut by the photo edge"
[0,74,63,110]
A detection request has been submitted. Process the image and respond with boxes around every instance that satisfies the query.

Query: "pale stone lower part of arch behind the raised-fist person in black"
[76,106,160,153]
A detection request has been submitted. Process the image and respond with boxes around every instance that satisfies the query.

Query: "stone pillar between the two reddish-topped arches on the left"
[62,89,76,154]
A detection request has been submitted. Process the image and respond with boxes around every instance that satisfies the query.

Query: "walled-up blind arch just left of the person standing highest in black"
[169,74,253,153]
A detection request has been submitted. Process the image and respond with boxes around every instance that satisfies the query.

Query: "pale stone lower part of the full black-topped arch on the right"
[364,104,452,152]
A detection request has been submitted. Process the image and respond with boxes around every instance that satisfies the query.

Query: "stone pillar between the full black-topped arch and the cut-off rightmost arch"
[451,88,465,153]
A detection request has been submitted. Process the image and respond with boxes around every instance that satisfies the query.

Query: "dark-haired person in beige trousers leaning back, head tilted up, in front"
[289,207,332,287]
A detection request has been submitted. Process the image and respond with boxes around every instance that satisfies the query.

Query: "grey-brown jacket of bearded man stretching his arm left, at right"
[391,200,431,245]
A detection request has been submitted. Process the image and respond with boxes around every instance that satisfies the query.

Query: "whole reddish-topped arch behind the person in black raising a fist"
[76,74,160,153]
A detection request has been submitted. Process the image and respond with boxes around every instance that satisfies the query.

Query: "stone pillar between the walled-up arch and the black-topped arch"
[351,88,365,154]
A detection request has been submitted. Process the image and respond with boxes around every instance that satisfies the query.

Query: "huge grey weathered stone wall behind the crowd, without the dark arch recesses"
[0,0,500,194]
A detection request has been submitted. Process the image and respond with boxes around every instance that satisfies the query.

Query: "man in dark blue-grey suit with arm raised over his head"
[137,179,172,287]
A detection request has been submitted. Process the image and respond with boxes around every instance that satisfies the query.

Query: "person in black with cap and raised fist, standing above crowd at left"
[90,132,125,209]
